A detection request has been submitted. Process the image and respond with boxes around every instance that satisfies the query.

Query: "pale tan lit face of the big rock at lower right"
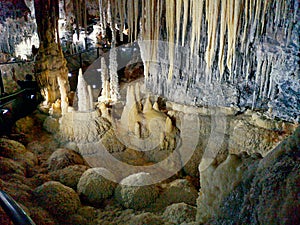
[197,153,257,223]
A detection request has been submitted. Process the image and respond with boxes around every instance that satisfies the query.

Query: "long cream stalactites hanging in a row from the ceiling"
[99,0,297,81]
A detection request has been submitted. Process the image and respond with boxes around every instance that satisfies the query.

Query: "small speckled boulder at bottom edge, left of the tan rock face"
[162,203,197,224]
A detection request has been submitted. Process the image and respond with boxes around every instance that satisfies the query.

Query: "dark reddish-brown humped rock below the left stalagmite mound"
[47,148,87,171]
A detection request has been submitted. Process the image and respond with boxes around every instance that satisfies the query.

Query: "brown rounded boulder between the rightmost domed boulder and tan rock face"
[155,179,198,208]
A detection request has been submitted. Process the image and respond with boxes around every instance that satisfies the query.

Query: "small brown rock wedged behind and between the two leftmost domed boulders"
[52,165,89,191]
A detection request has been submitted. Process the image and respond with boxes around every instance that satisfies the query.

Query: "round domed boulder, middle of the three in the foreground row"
[77,168,116,205]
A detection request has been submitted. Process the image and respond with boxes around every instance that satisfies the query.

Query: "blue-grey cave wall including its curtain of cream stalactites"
[99,0,300,121]
